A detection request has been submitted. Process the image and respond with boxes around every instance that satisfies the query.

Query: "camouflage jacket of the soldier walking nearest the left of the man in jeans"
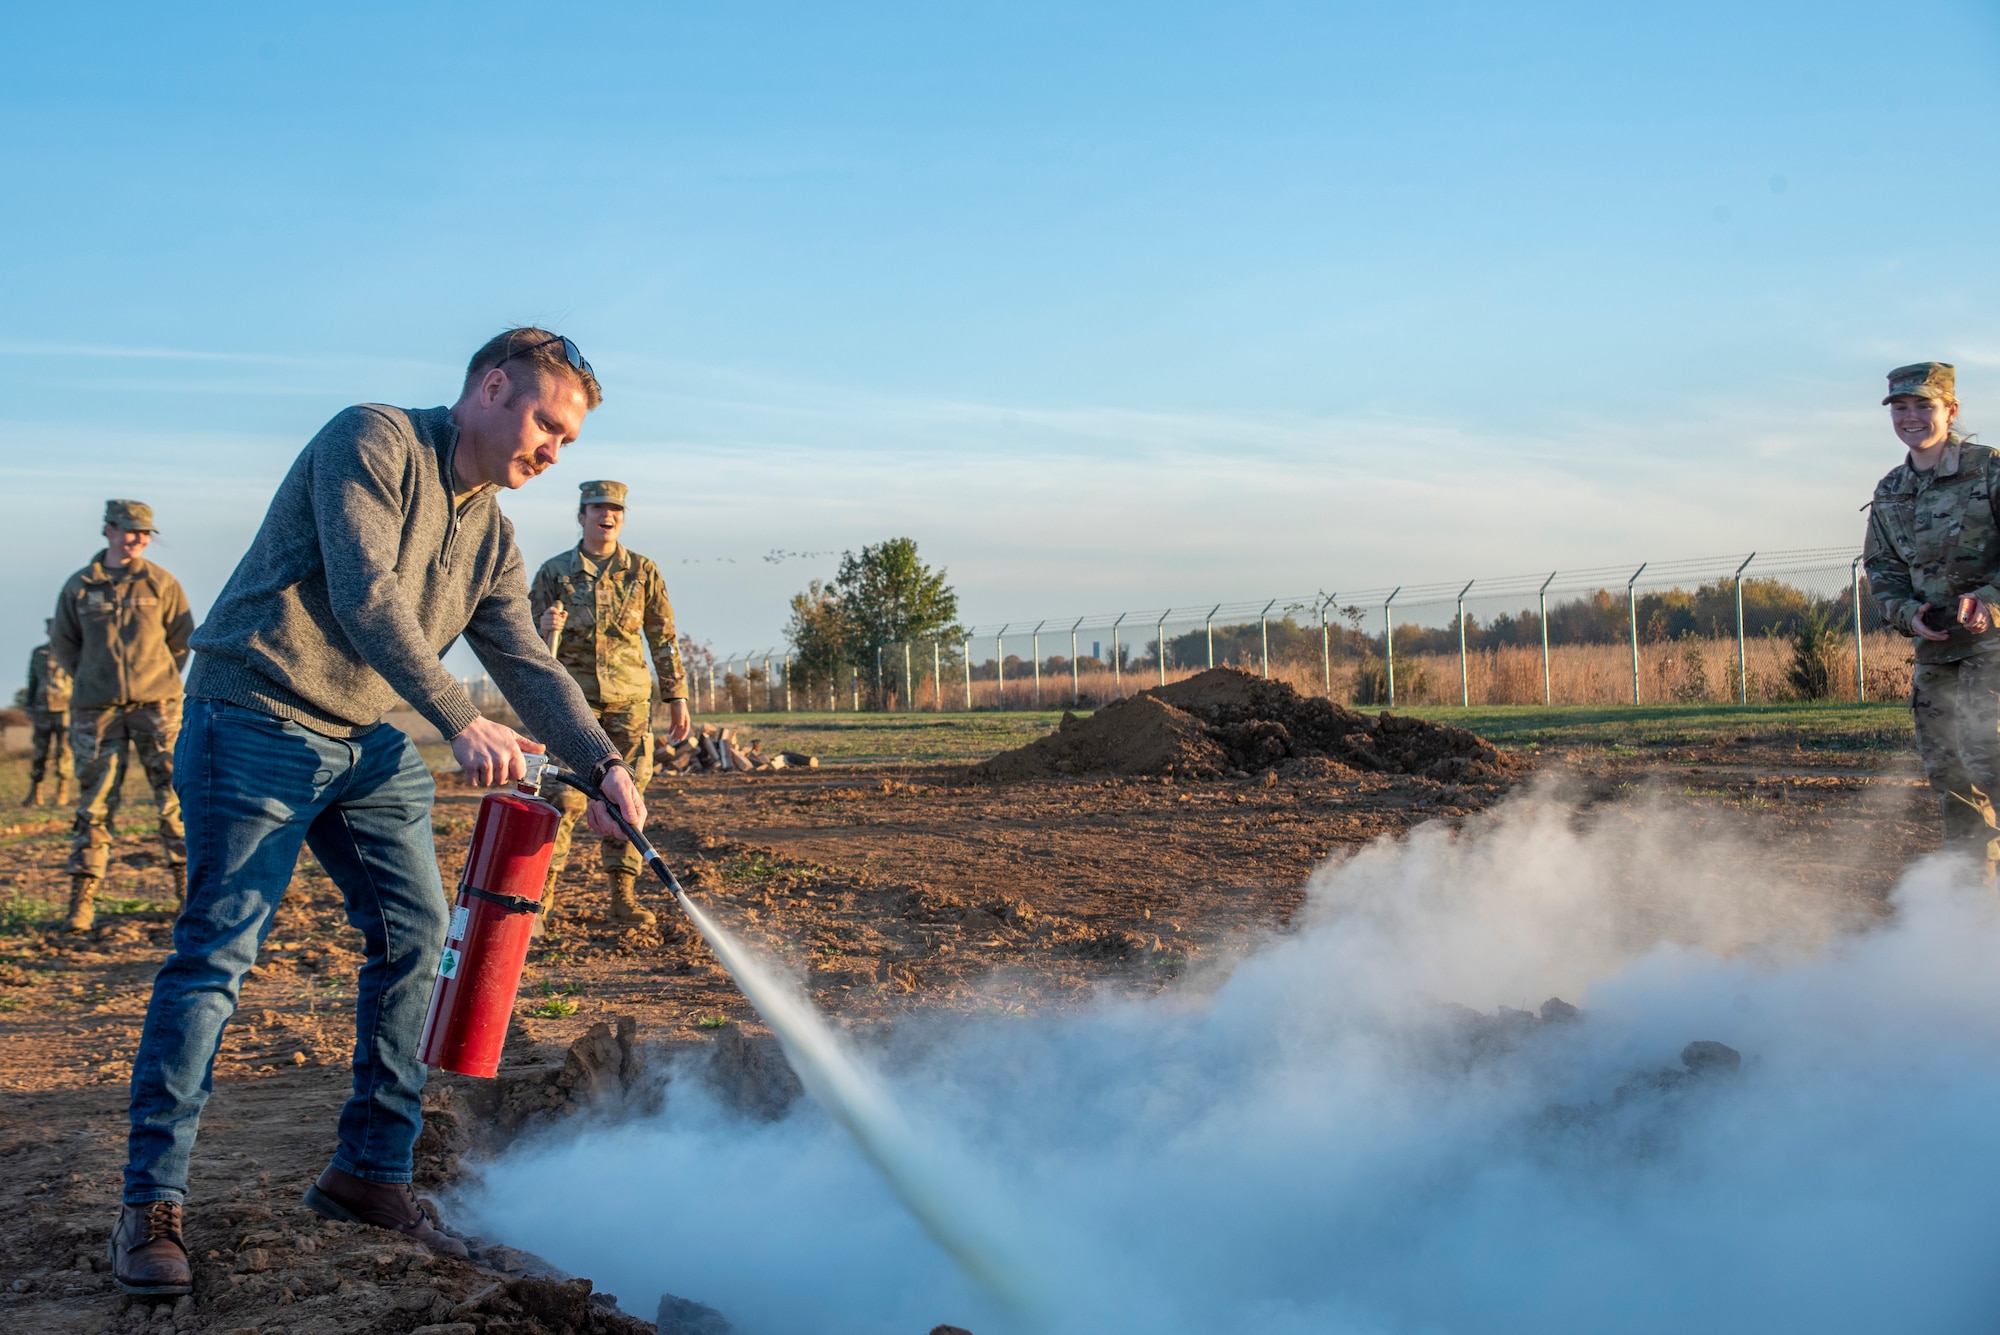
[48,552,194,709]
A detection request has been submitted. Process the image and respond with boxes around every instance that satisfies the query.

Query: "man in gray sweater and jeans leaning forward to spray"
[110,328,646,1295]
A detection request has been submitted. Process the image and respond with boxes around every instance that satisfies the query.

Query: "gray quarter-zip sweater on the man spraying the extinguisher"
[188,404,616,769]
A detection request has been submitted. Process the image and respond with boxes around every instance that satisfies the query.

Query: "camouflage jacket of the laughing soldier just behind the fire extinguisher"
[528,544,688,705]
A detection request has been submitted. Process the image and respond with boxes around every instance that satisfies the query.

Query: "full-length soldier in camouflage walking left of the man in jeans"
[48,500,194,931]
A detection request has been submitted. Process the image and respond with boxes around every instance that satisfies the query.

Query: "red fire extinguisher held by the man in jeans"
[418,755,562,1079]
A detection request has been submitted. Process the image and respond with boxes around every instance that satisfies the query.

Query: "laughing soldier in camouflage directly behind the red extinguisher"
[528,482,688,925]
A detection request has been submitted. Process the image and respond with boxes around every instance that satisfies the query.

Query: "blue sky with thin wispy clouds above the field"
[0,2,2000,679]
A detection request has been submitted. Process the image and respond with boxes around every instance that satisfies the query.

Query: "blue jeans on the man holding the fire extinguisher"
[124,699,446,1205]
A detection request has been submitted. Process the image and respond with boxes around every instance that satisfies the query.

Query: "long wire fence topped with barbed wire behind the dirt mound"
[460,548,1908,713]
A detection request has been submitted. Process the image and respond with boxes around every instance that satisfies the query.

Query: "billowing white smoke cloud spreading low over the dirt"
[460,795,2000,1335]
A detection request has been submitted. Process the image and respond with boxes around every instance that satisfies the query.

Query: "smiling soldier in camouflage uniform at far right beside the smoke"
[1862,362,2000,859]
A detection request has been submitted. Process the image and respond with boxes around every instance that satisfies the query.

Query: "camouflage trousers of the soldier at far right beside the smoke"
[1910,654,2000,843]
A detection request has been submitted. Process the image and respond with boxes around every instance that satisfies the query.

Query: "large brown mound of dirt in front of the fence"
[972,668,1520,783]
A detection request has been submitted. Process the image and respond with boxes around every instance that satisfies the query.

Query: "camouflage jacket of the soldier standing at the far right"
[1862,442,2000,664]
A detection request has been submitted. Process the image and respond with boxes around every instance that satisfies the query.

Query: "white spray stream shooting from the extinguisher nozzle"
[676,891,1030,1311]
